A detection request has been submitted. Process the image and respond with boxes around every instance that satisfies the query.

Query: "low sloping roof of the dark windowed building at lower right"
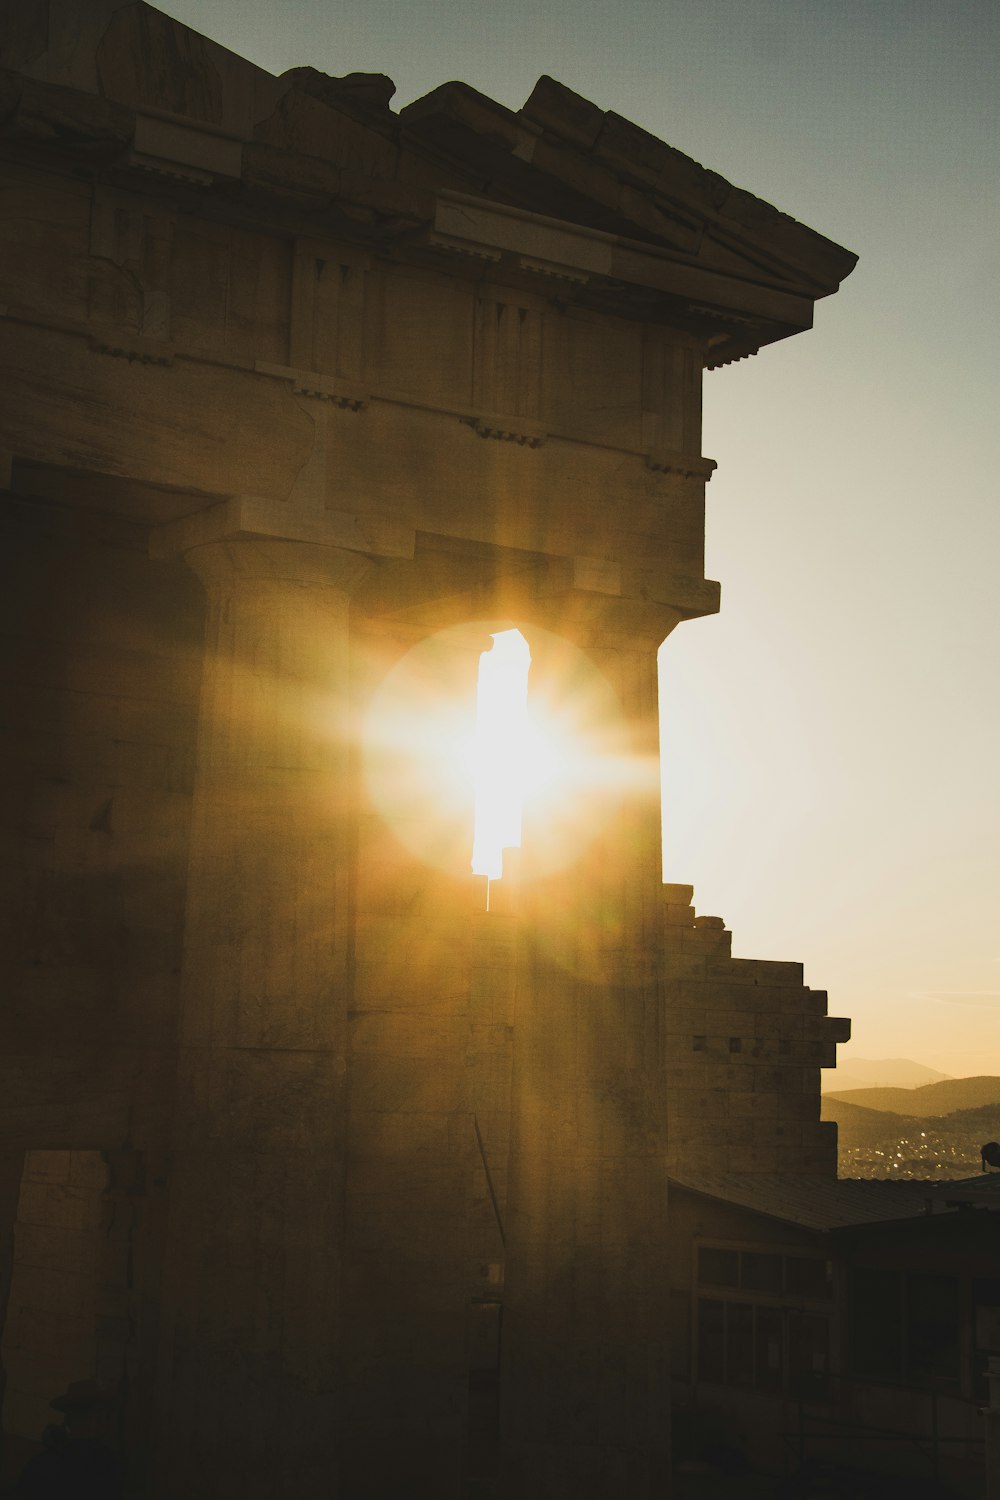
[670,1172,1000,1230]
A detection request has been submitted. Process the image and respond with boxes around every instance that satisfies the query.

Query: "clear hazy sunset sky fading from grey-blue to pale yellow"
[160,0,1000,1082]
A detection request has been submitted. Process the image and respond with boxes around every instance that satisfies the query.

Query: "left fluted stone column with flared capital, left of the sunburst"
[157,539,366,1500]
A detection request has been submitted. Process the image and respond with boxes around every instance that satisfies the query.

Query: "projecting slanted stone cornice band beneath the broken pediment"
[0,60,847,363]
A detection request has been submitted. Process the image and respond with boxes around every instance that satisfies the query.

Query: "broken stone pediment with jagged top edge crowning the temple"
[1,0,856,365]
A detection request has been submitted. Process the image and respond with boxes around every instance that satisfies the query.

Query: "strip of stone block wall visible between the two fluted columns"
[345,630,499,1500]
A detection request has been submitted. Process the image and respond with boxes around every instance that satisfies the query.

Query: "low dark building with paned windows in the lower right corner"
[670,1170,1000,1497]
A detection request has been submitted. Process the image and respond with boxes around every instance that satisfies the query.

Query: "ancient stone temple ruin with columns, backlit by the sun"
[0,0,855,1500]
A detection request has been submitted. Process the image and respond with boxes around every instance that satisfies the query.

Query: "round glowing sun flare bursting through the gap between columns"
[363,626,622,882]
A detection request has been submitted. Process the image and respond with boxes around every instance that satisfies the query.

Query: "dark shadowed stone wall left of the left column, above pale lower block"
[0,500,202,1149]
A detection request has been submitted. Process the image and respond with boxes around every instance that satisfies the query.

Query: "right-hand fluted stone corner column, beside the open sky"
[501,633,669,1500]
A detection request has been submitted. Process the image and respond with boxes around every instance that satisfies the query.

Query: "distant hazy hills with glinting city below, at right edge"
[823,1059,1000,1181]
